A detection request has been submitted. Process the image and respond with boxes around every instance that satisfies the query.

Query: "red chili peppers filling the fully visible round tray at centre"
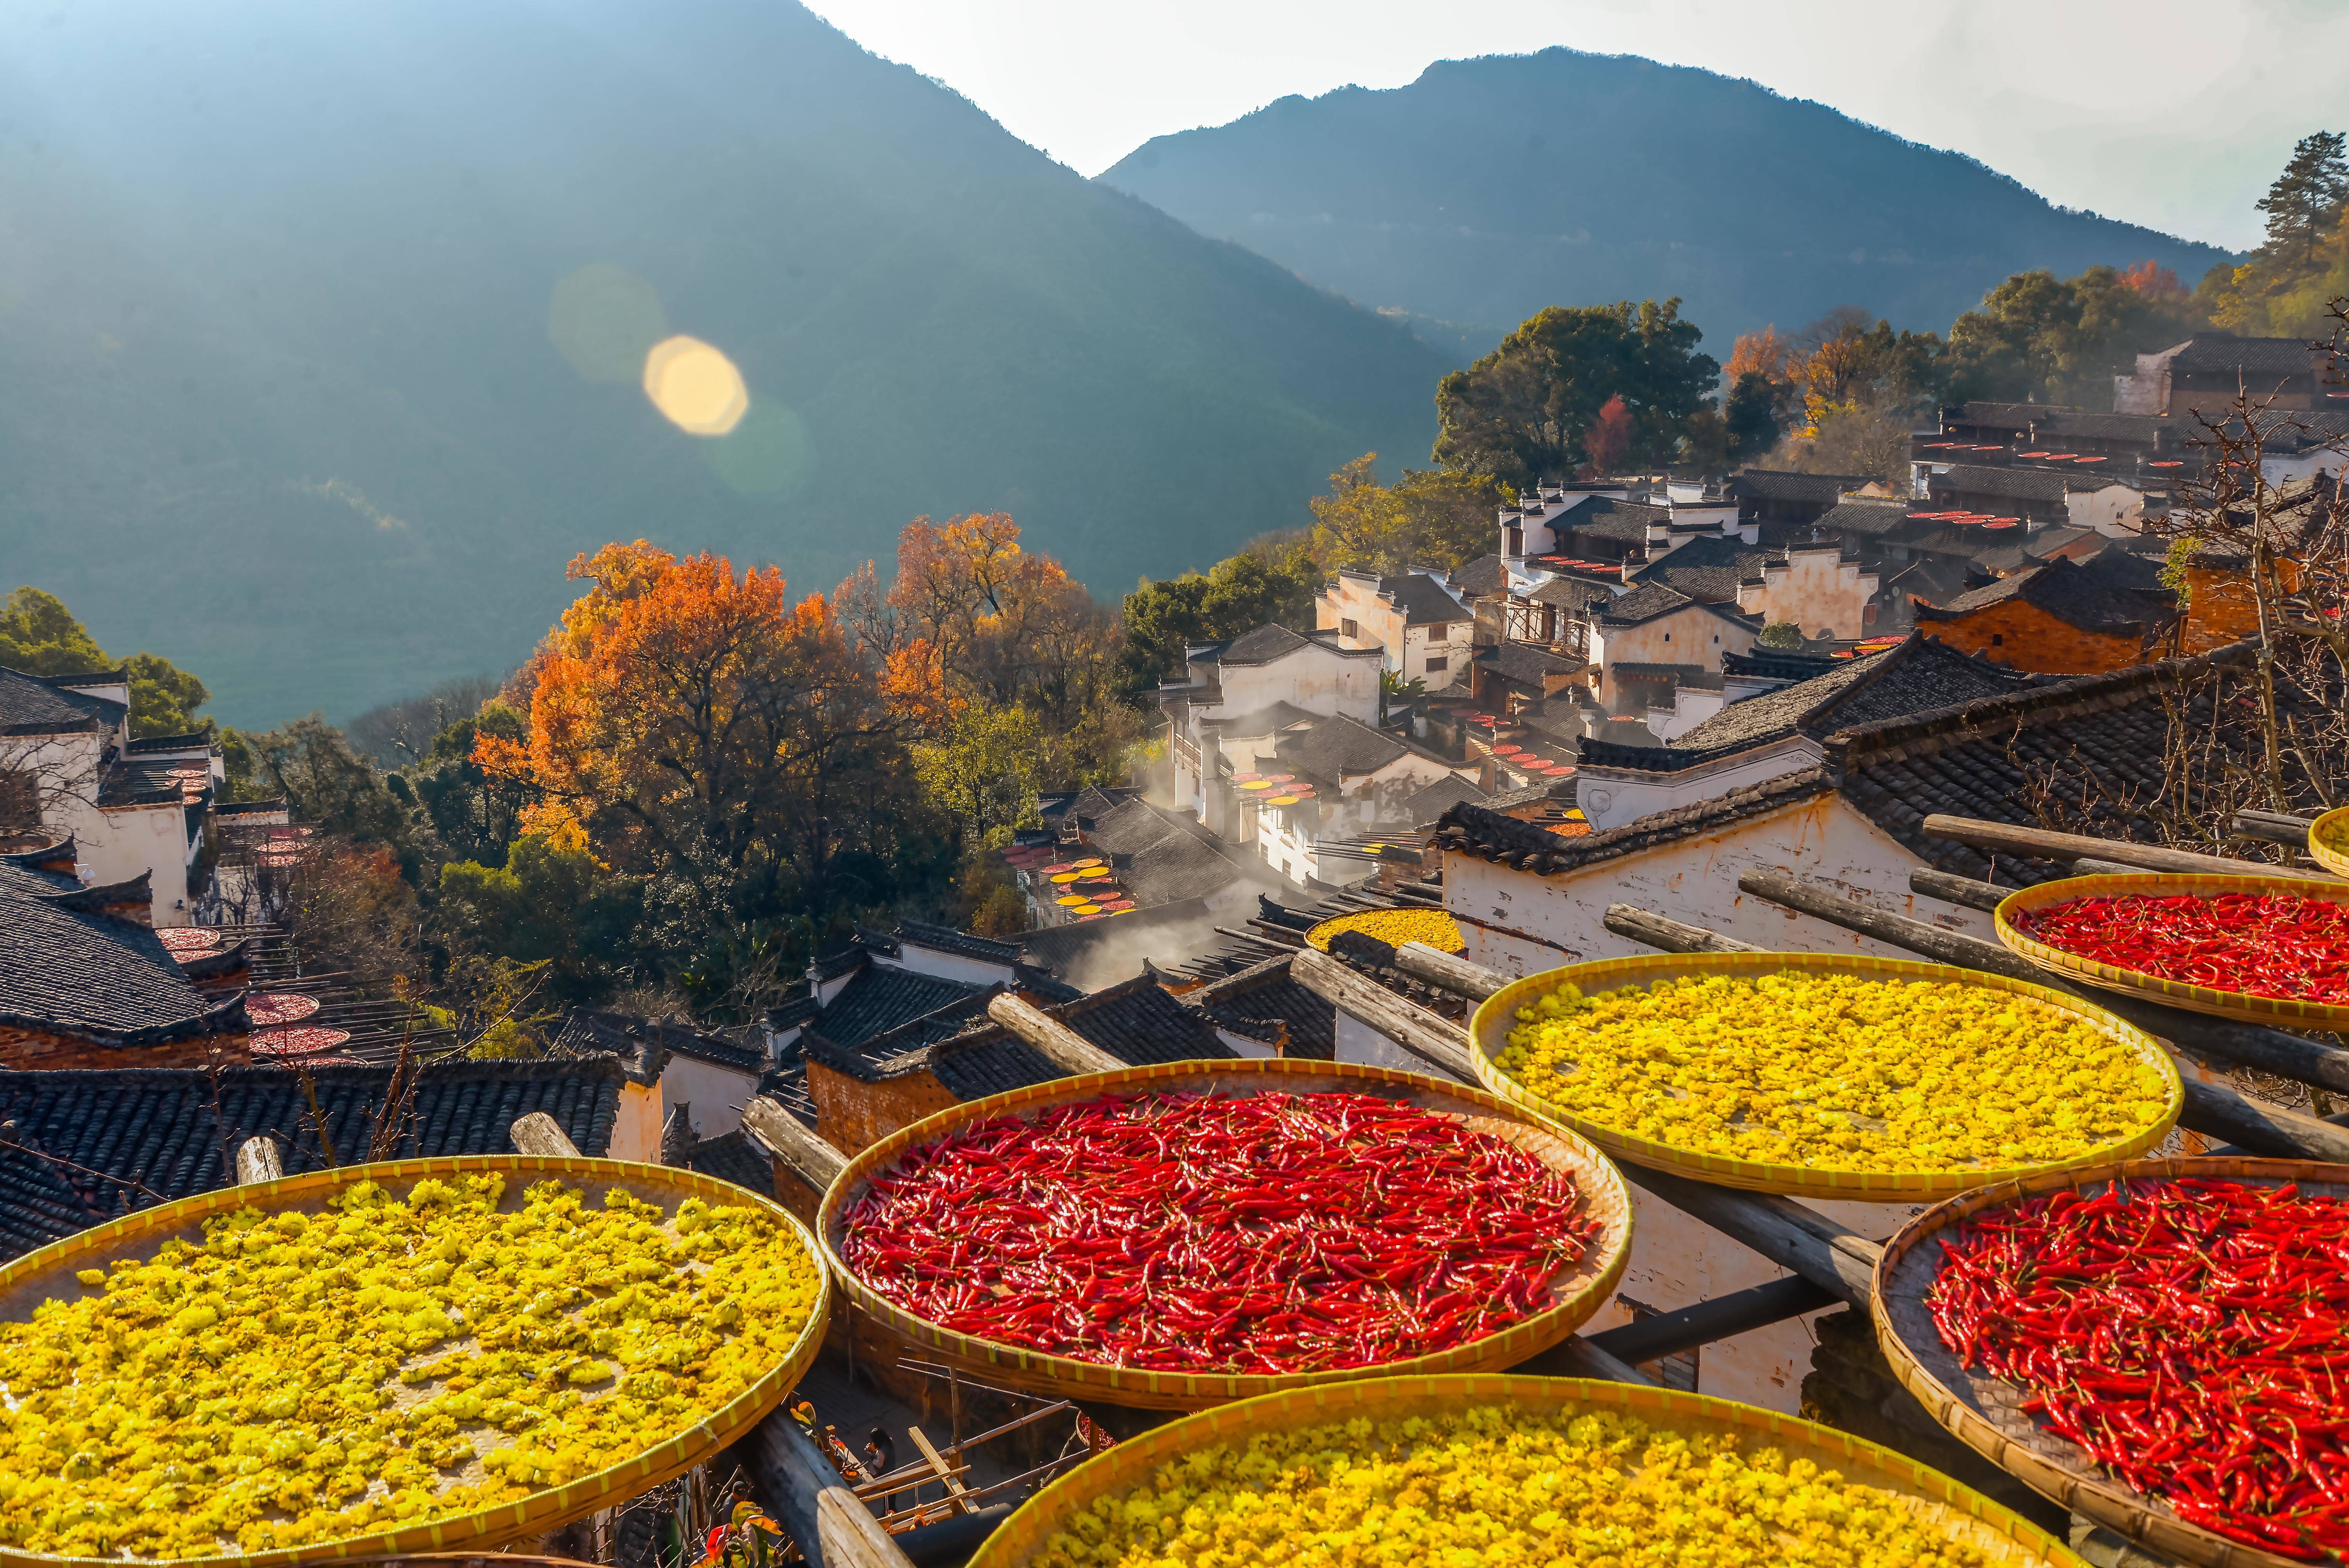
[841,1094,1600,1376]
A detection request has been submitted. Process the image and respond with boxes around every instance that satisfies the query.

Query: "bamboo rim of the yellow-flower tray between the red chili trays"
[1468,953,2185,1204]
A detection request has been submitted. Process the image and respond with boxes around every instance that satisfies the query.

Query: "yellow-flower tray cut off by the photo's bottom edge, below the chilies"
[970,1376,2081,1568]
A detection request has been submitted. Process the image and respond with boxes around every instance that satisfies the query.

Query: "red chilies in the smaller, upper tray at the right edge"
[2013,892,2349,1005]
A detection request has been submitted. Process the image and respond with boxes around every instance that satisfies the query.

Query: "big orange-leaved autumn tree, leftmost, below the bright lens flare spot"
[474,540,911,943]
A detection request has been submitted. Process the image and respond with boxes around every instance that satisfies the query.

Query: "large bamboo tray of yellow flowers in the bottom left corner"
[0,1155,829,1568]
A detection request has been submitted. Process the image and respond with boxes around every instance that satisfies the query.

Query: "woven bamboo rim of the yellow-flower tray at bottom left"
[0,1155,832,1568]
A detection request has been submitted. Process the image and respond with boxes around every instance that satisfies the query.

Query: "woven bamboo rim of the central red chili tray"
[815,1058,1630,1411]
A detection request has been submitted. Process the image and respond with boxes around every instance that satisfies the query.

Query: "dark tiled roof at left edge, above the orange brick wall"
[0,864,247,1047]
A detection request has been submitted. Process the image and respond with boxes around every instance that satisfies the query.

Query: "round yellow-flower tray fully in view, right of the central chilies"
[1470,953,2185,1202]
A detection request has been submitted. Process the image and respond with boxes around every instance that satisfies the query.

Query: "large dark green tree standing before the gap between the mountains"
[1435,298,1722,488]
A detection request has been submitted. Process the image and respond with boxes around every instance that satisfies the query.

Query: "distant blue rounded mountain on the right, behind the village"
[1099,49,2227,359]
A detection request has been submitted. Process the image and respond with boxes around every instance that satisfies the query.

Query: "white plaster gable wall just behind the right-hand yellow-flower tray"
[1445,796,1994,974]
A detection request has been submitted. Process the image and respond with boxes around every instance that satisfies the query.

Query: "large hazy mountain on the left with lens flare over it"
[0,0,1447,723]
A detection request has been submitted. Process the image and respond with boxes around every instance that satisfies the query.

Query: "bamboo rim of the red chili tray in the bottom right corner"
[1872,1157,2349,1568]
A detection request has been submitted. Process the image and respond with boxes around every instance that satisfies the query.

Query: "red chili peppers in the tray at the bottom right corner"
[1926,1181,2349,1559]
